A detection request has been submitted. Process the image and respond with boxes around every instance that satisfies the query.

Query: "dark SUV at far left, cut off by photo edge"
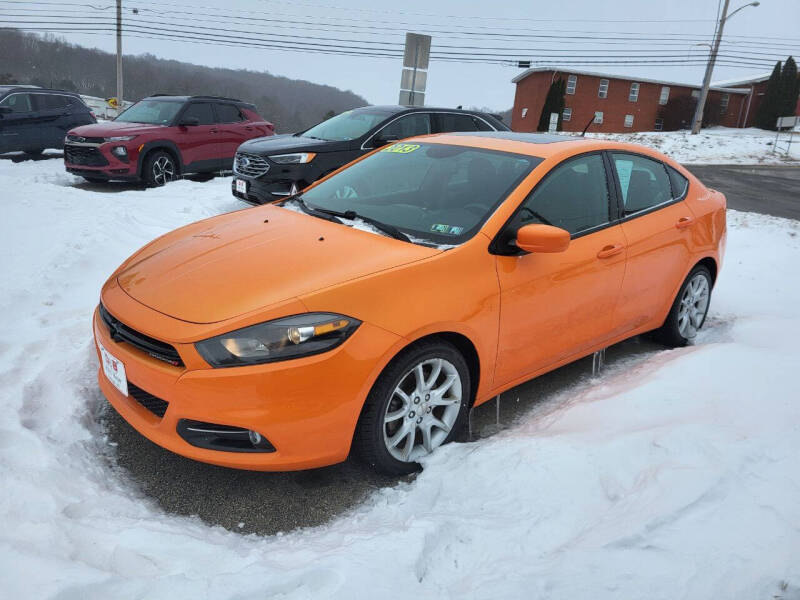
[0,85,97,154]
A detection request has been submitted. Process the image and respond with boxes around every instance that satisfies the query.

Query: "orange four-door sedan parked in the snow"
[94,132,725,474]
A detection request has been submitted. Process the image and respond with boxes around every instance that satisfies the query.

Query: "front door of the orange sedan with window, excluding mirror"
[494,152,626,385]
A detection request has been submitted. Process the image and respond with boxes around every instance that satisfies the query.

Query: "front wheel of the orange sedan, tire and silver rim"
[353,341,471,475]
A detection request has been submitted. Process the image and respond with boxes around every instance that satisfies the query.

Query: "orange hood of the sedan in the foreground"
[116,205,441,323]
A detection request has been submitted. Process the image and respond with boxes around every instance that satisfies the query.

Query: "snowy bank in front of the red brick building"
[586,127,800,165]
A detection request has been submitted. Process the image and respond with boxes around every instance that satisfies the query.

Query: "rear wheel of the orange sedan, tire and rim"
[653,265,714,348]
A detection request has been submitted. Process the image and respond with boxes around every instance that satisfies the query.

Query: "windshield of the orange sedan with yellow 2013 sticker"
[290,143,542,245]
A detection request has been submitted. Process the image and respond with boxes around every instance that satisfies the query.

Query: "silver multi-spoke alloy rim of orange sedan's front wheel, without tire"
[383,358,462,462]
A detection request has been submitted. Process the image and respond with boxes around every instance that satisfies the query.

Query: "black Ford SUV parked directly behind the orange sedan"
[231,106,509,204]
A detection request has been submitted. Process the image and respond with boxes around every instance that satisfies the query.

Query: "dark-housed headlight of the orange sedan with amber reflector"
[195,313,361,367]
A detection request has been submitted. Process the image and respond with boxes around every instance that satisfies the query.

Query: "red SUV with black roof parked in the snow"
[64,95,275,186]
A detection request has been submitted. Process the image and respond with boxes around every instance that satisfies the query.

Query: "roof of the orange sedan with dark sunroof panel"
[403,131,677,164]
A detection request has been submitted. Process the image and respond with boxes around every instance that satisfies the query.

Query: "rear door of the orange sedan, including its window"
[609,152,694,333]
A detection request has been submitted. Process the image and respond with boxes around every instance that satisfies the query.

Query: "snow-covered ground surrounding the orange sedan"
[0,160,800,600]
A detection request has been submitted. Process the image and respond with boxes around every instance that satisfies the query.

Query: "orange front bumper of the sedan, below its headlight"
[93,311,399,471]
